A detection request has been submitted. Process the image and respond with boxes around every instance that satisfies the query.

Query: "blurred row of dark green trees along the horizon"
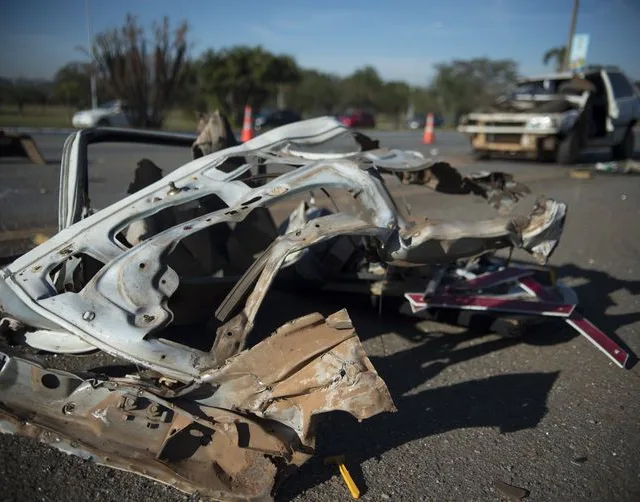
[0,15,636,127]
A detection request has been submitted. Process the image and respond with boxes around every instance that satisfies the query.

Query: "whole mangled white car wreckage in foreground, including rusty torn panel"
[0,114,632,500]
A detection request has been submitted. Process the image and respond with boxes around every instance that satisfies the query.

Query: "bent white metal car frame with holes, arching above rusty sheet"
[0,117,566,383]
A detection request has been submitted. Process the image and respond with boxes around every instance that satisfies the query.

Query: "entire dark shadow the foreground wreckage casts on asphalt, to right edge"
[272,265,640,502]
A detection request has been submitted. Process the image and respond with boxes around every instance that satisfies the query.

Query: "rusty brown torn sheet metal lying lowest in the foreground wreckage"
[0,311,395,501]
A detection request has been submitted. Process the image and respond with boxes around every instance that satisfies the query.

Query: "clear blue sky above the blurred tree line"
[0,0,640,84]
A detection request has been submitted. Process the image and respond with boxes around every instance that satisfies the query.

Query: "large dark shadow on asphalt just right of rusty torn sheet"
[276,302,559,501]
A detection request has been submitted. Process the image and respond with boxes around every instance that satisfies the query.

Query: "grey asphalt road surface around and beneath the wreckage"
[0,133,640,502]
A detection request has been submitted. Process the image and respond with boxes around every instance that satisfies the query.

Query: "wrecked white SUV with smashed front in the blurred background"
[458,67,640,164]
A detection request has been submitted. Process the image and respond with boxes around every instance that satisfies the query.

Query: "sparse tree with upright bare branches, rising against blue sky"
[92,15,188,127]
